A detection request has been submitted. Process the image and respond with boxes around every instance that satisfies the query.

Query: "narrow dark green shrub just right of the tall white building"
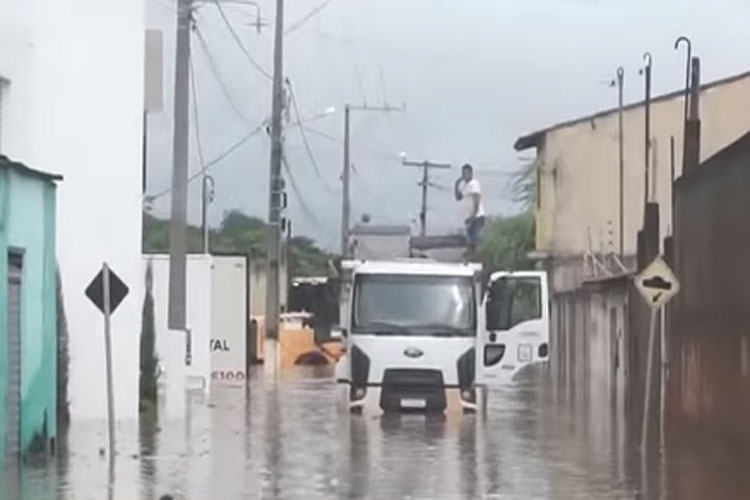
[138,262,159,413]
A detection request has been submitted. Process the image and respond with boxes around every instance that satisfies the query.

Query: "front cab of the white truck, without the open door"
[337,259,482,413]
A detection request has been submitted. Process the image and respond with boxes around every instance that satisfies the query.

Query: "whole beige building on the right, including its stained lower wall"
[515,72,750,438]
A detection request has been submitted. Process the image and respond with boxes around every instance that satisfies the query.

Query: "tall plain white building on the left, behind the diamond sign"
[0,0,144,421]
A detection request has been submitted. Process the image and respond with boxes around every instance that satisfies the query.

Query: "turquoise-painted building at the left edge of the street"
[0,156,62,463]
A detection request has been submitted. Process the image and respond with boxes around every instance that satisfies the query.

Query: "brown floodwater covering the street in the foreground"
[2,368,750,500]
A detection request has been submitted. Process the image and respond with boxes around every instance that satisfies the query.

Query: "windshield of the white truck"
[352,274,475,336]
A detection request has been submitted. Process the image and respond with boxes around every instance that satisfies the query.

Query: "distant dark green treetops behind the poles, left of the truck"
[143,210,331,277]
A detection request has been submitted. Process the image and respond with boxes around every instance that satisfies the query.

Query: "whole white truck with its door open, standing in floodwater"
[336,229,549,413]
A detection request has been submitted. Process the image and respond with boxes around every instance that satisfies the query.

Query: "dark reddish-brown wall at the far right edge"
[667,130,750,447]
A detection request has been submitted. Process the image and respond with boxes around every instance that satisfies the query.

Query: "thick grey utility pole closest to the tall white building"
[168,0,193,330]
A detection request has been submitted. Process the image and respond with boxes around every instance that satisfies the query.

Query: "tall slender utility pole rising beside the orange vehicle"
[265,0,284,352]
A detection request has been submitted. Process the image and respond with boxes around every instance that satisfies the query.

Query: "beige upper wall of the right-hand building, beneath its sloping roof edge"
[515,68,750,291]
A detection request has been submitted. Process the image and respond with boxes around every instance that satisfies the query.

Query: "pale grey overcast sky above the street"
[146,0,750,248]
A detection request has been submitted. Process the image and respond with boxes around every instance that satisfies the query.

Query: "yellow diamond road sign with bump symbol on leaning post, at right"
[635,256,680,463]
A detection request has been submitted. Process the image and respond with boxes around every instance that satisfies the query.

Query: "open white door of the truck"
[477,271,549,385]
